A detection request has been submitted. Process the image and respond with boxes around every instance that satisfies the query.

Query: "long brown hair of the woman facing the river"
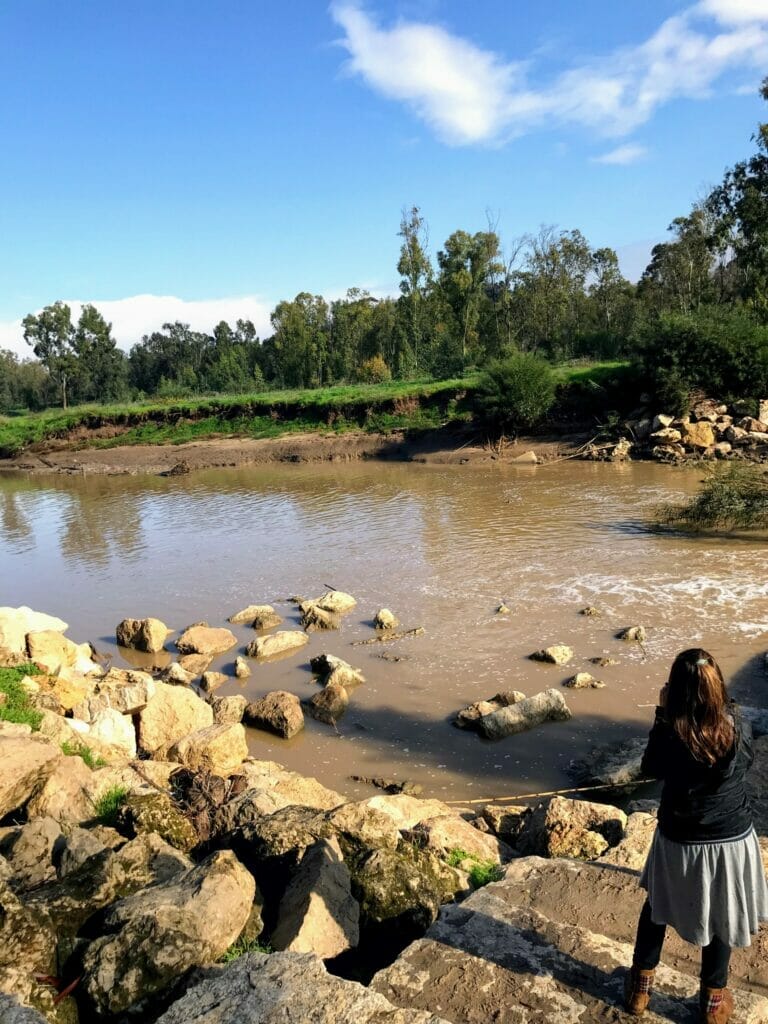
[665,647,735,764]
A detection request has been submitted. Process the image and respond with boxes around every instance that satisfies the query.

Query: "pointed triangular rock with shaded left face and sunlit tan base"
[271,839,359,958]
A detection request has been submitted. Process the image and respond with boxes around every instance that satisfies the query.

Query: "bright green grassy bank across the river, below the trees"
[0,362,638,459]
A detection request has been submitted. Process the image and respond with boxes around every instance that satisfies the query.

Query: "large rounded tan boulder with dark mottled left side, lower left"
[81,851,256,1015]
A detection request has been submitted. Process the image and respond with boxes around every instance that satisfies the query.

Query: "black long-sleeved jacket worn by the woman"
[641,705,755,843]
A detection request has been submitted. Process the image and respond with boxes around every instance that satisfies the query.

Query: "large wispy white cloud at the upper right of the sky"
[331,0,768,145]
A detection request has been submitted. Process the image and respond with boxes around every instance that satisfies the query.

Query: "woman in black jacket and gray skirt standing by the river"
[627,648,768,1024]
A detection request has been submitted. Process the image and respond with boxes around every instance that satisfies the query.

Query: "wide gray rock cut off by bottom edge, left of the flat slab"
[153,953,446,1024]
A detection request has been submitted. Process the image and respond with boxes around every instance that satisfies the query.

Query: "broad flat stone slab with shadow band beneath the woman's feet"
[371,858,768,1024]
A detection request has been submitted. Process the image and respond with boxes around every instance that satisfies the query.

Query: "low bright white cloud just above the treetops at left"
[0,295,271,356]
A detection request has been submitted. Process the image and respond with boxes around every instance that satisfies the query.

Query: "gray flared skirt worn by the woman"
[640,828,768,946]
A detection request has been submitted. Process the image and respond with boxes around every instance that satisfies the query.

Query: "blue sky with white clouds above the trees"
[0,0,768,354]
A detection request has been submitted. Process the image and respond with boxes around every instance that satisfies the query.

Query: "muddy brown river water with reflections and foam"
[0,462,768,799]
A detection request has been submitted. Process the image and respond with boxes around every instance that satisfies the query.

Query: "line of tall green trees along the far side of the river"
[6,78,768,411]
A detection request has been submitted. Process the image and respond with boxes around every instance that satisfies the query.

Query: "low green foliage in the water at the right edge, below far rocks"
[656,462,768,530]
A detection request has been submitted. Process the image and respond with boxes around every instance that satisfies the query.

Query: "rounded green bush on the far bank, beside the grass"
[475,352,555,430]
